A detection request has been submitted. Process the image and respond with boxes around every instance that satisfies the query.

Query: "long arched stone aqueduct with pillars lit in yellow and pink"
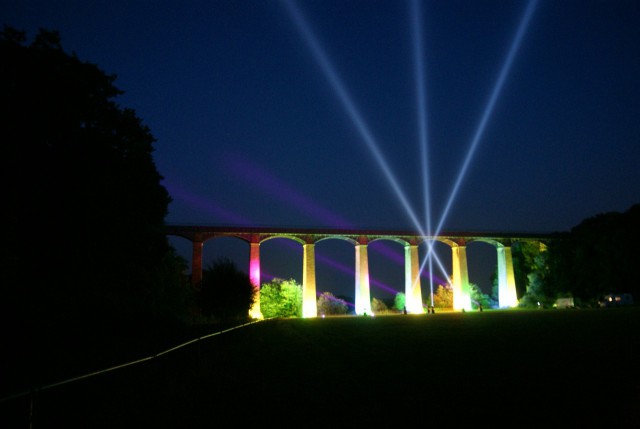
[166,225,552,318]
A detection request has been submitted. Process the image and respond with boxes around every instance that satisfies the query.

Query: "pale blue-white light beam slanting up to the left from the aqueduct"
[283,0,425,235]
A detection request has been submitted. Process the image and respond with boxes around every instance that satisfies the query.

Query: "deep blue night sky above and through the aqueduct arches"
[6,0,640,299]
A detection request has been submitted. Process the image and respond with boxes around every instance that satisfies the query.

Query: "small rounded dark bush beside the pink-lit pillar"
[198,258,255,321]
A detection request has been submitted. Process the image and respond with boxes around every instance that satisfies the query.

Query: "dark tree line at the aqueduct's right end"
[513,204,640,307]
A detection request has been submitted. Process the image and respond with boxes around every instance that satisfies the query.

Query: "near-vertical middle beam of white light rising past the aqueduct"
[410,0,433,305]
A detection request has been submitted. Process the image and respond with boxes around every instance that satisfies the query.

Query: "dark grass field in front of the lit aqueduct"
[5,307,640,429]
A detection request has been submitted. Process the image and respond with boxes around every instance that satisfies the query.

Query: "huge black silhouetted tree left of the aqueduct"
[0,27,186,326]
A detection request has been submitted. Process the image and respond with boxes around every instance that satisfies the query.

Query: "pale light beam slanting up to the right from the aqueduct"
[420,0,538,280]
